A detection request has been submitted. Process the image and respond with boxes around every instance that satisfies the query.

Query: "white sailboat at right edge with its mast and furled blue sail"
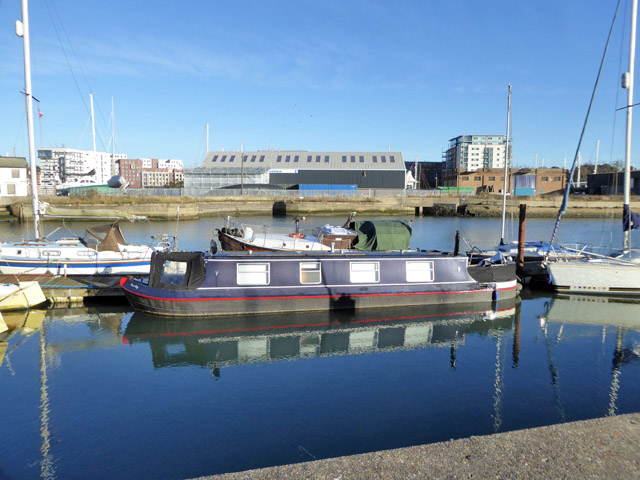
[548,0,640,297]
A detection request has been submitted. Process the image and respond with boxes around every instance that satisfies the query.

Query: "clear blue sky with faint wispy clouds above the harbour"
[0,0,640,171]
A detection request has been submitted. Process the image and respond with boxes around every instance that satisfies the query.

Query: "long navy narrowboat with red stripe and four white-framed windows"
[120,250,518,317]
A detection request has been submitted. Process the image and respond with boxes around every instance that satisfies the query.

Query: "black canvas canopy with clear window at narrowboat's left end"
[149,252,206,290]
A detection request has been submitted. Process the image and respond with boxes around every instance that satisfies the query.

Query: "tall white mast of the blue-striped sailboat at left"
[16,0,41,240]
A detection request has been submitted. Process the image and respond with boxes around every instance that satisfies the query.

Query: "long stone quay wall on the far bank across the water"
[5,195,640,221]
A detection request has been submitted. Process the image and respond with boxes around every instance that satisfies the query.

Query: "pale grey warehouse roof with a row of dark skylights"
[202,150,405,171]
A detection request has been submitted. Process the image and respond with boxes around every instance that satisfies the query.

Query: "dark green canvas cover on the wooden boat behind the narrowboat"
[350,220,411,252]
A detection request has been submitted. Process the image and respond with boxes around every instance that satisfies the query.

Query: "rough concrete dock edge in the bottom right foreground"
[201,413,640,480]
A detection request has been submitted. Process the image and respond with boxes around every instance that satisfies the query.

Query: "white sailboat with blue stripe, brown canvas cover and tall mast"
[0,0,169,275]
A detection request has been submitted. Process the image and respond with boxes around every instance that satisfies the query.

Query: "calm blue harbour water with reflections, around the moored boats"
[0,218,640,479]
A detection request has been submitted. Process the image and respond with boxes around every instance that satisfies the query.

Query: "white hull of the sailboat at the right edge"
[547,260,640,296]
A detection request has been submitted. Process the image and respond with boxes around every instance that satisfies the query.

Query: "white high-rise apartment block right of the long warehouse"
[443,135,506,171]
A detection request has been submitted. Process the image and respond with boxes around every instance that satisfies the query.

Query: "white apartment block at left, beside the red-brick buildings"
[38,147,127,185]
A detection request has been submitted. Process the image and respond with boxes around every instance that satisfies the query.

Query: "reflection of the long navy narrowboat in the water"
[123,299,516,377]
